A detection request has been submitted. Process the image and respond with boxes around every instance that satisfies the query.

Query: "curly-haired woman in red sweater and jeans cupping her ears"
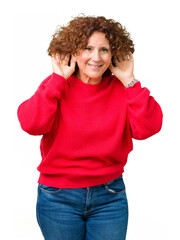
[18,16,162,240]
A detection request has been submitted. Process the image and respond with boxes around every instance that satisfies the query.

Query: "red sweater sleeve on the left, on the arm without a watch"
[17,73,66,135]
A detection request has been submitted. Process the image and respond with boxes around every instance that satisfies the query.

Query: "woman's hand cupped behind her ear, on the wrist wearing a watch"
[109,52,135,86]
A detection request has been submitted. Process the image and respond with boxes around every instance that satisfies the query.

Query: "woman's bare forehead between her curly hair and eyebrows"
[88,32,109,47]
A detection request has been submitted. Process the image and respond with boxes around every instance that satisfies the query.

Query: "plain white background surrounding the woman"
[0,0,180,240]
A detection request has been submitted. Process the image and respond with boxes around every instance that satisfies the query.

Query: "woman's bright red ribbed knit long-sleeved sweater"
[18,73,162,188]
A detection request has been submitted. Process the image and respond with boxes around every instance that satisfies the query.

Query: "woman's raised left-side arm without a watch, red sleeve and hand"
[18,54,75,135]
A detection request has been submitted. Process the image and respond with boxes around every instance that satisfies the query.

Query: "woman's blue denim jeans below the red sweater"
[36,176,128,240]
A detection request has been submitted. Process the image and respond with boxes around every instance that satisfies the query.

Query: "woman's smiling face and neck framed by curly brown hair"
[76,32,112,84]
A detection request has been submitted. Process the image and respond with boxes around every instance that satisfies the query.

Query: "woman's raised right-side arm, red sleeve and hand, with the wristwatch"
[110,52,163,139]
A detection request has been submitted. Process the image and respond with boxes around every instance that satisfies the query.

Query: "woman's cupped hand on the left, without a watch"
[51,53,76,79]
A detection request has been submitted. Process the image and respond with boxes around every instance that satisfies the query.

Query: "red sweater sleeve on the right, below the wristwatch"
[125,82,163,140]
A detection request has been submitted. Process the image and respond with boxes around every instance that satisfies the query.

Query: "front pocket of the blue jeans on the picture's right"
[104,177,126,194]
